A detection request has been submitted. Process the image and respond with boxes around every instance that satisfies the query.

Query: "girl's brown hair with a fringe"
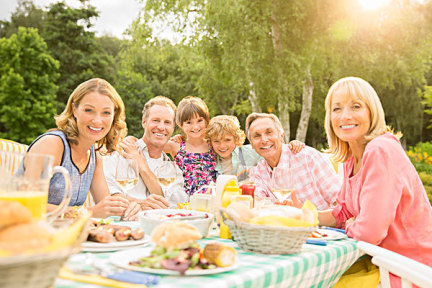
[176,96,210,127]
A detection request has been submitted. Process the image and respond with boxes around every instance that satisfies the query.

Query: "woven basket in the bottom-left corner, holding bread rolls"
[0,213,89,288]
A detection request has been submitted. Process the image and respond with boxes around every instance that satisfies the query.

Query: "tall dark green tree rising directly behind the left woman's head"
[42,0,115,112]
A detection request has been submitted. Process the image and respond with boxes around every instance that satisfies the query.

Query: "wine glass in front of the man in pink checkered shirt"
[270,167,294,203]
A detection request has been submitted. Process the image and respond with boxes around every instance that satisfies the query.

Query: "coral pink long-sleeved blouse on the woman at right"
[333,133,432,287]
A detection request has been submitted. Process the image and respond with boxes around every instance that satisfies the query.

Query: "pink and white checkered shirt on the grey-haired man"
[250,144,342,210]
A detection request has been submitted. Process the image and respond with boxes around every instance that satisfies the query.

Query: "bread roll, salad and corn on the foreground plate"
[129,221,235,275]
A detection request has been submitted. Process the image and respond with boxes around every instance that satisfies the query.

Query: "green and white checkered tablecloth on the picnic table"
[54,238,362,288]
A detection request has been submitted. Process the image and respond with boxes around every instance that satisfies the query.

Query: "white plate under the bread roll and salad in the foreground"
[109,247,238,276]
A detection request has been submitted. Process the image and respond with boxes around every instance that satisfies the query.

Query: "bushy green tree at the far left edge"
[0,27,59,143]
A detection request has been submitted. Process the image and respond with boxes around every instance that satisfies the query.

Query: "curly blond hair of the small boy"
[205,115,246,146]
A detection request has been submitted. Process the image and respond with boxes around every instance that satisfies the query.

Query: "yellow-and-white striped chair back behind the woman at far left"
[0,138,95,207]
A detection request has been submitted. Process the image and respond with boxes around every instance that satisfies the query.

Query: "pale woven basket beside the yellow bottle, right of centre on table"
[220,208,318,254]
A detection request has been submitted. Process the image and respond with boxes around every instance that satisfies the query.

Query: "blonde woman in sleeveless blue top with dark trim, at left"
[22,78,140,219]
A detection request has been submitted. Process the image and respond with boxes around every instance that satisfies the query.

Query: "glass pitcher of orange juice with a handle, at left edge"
[0,151,72,222]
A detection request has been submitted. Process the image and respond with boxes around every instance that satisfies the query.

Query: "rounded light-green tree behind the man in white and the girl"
[115,41,201,137]
